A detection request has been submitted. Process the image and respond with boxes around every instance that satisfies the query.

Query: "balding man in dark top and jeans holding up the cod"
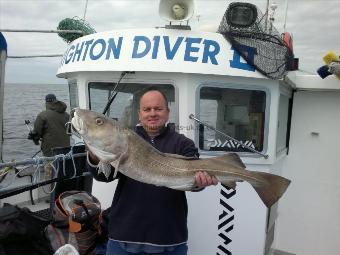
[87,88,217,255]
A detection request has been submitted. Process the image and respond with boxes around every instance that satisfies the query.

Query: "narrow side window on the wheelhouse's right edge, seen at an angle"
[276,94,291,153]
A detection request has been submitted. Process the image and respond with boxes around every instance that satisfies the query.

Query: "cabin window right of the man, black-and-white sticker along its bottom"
[199,87,266,152]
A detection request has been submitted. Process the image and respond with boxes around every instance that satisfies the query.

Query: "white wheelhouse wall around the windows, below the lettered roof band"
[67,72,294,255]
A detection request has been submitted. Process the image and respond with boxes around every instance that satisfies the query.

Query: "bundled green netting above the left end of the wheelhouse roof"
[57,17,96,43]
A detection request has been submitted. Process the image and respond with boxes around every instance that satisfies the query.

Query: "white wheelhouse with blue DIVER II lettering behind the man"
[57,21,292,254]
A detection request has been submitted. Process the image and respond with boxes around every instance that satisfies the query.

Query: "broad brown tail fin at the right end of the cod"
[251,172,290,208]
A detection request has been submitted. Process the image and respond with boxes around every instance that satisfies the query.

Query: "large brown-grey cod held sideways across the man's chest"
[72,108,290,207]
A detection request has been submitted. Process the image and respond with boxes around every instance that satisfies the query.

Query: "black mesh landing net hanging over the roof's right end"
[218,3,294,79]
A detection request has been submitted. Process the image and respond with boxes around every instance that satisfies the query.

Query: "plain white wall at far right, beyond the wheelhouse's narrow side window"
[275,90,340,255]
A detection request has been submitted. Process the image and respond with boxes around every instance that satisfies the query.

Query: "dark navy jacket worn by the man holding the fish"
[88,126,199,245]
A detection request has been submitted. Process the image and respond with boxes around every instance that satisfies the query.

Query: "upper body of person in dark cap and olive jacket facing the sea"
[28,94,70,157]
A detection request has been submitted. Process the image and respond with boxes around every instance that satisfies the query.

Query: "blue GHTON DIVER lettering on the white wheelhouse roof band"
[61,35,220,65]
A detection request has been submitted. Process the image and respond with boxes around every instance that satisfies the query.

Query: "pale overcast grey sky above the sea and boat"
[0,0,340,84]
